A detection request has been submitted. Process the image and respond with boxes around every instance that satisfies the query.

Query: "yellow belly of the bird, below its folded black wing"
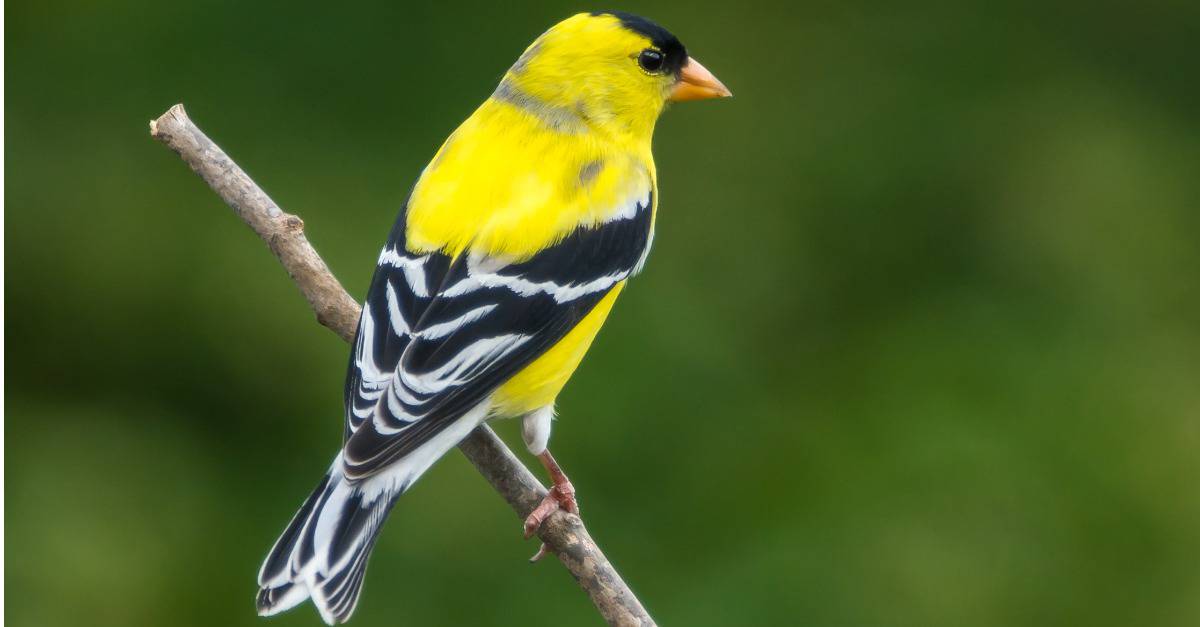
[492,281,625,416]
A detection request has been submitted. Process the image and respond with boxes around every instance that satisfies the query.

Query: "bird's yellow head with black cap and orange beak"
[494,12,732,141]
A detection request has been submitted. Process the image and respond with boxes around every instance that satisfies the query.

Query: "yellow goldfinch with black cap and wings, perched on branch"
[257,12,732,625]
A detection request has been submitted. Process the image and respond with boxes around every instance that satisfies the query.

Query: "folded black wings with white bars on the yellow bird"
[343,189,653,478]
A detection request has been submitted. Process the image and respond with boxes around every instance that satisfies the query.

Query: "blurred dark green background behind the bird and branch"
[5,0,1200,627]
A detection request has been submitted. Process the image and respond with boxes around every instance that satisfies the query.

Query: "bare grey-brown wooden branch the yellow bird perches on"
[150,105,655,626]
